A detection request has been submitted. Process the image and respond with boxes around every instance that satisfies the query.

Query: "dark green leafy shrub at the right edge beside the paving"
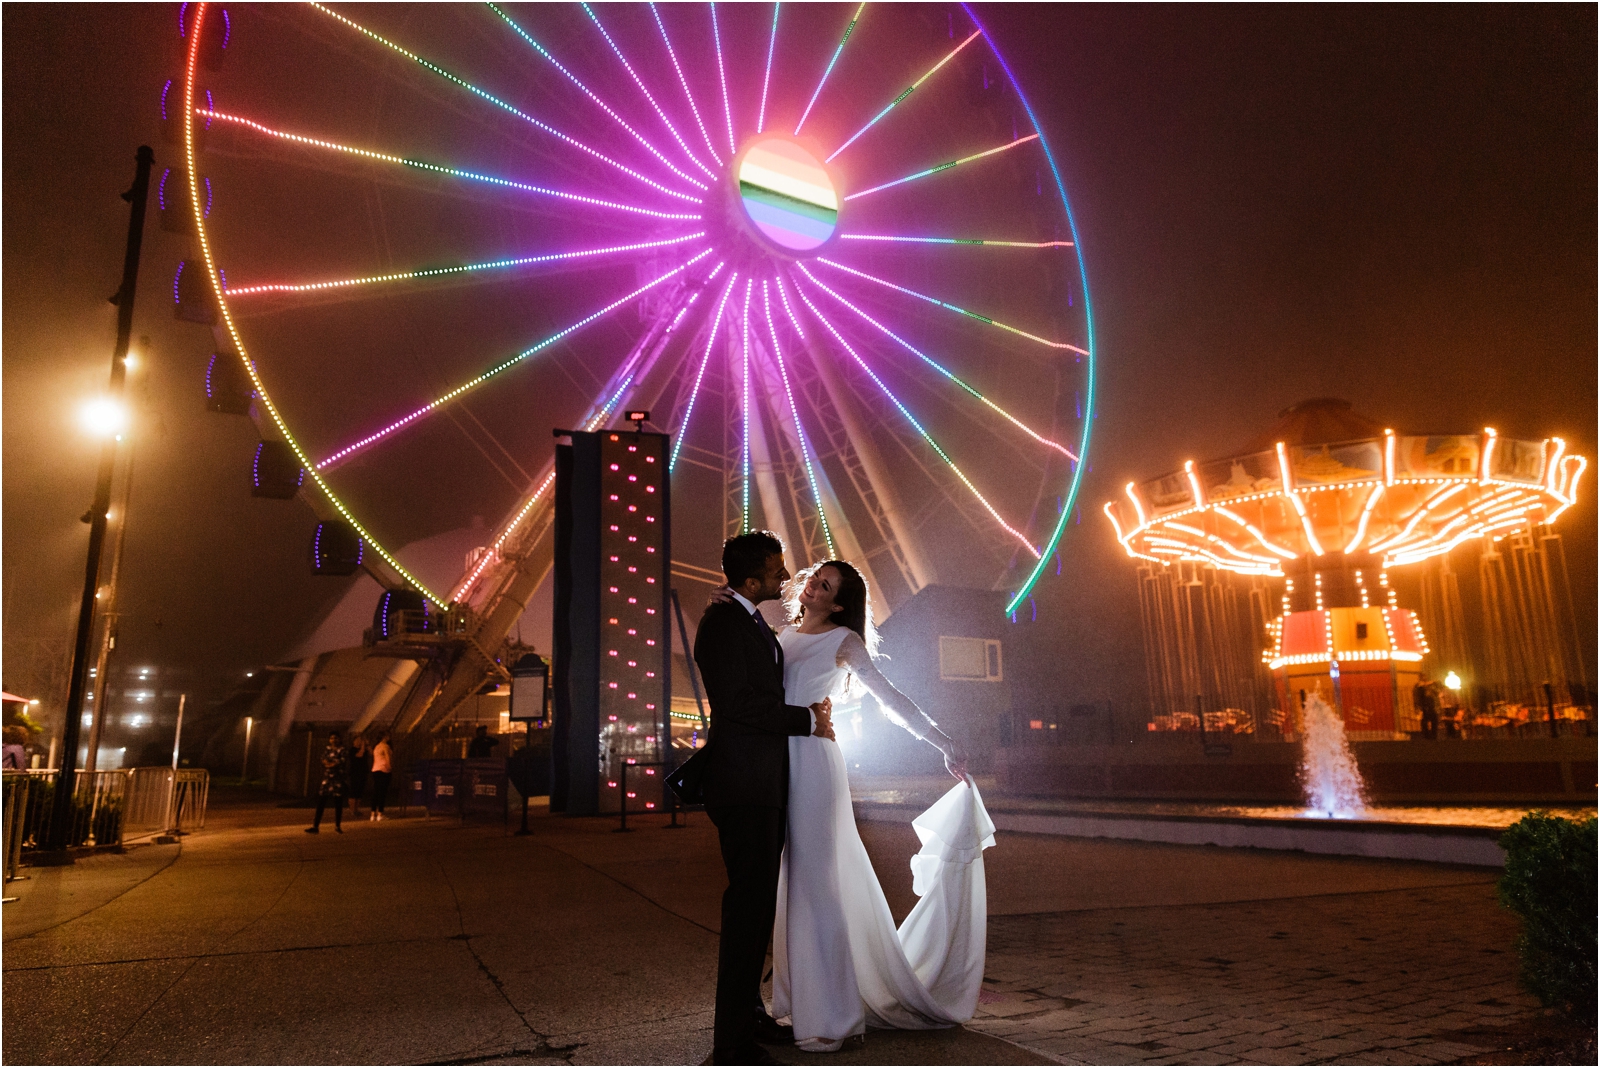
[1499,812,1595,1018]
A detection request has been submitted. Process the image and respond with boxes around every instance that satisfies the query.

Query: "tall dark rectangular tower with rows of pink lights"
[550,430,672,815]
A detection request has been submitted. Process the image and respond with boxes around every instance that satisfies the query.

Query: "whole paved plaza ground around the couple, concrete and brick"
[3,791,1536,1063]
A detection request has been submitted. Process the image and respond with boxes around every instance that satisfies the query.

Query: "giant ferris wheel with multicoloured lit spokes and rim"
[178,3,1094,725]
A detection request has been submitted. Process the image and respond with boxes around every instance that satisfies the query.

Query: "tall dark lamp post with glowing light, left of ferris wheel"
[34,145,155,865]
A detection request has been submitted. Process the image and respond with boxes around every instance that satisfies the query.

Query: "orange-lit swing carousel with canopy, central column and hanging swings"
[1104,400,1587,737]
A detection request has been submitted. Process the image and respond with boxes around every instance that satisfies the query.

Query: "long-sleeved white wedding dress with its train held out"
[773,627,994,1052]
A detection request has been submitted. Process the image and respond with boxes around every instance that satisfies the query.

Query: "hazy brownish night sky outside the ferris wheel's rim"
[0,5,1597,729]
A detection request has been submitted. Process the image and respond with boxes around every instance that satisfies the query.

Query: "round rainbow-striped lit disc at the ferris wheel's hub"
[739,137,838,253]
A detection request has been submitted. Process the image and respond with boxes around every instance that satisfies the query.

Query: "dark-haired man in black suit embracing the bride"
[694,531,834,1065]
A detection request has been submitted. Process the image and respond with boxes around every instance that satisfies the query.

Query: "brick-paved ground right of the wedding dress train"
[971,876,1538,1065]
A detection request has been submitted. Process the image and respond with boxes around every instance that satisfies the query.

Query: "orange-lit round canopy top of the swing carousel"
[1104,400,1587,576]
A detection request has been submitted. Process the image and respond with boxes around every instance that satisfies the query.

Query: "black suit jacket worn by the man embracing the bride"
[694,601,811,807]
